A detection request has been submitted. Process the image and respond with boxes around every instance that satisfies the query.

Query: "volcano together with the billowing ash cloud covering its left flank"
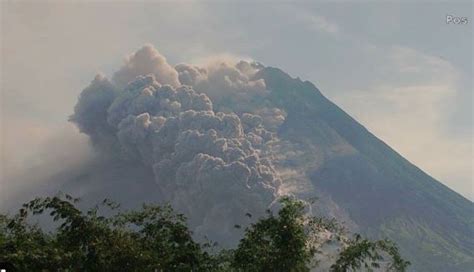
[6,45,474,271]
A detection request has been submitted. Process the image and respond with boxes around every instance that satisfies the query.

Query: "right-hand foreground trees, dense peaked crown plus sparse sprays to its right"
[231,197,409,272]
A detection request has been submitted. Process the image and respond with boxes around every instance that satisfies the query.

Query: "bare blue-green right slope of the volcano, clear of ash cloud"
[256,68,474,271]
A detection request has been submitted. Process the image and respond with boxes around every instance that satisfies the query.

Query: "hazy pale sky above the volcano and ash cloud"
[0,1,474,200]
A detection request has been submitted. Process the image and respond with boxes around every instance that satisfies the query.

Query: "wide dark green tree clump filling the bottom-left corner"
[0,196,215,271]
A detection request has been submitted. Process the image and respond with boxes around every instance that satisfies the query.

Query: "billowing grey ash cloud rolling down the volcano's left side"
[71,46,285,244]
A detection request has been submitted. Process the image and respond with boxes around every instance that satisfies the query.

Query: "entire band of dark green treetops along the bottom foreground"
[0,195,409,271]
